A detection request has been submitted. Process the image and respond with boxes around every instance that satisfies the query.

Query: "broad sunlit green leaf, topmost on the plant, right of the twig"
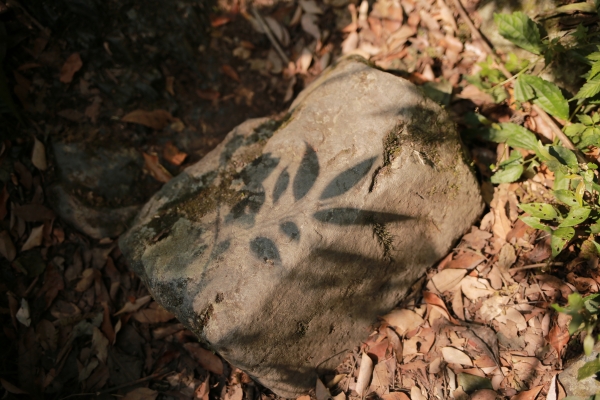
[494,11,544,54]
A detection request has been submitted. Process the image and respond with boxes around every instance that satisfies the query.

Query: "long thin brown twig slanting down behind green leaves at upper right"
[453,0,587,162]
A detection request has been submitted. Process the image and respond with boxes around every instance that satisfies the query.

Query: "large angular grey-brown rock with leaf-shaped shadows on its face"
[120,59,483,397]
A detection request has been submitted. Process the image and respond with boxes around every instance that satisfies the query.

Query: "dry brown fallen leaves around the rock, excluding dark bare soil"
[0,0,600,400]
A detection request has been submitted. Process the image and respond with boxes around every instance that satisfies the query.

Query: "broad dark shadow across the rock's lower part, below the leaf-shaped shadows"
[208,237,442,393]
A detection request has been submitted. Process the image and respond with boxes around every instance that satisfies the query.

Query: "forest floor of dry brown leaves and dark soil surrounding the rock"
[0,0,600,400]
